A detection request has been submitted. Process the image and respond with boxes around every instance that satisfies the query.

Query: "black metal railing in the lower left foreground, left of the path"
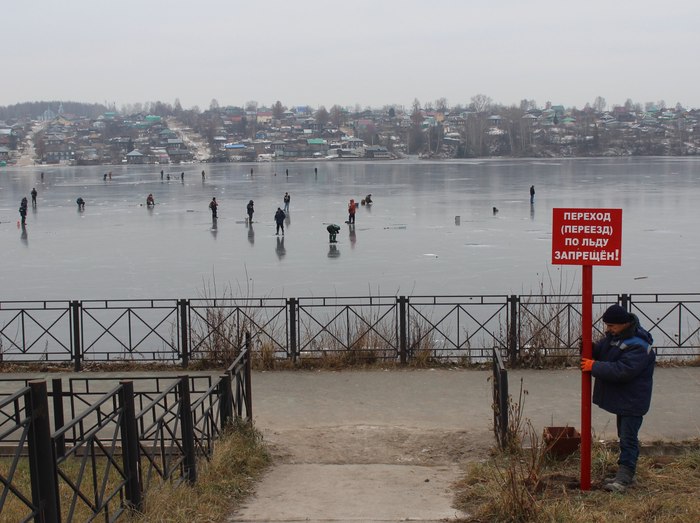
[0,344,252,522]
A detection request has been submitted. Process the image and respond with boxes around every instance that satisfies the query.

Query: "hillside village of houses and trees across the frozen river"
[0,100,700,165]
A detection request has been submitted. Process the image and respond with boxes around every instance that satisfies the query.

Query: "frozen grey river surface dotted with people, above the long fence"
[0,158,700,300]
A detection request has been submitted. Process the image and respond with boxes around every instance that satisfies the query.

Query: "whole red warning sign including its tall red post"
[552,209,622,490]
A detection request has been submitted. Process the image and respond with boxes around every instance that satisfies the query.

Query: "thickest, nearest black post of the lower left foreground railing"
[24,381,61,523]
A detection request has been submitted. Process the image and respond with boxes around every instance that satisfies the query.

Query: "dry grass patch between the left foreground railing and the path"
[130,423,270,523]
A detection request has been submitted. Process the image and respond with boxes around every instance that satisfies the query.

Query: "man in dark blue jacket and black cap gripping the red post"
[581,305,656,492]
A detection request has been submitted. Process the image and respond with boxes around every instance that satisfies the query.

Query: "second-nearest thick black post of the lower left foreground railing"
[119,380,142,511]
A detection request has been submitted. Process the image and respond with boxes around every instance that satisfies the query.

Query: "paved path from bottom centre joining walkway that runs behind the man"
[229,368,700,522]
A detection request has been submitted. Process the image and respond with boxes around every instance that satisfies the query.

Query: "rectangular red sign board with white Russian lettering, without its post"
[552,209,622,265]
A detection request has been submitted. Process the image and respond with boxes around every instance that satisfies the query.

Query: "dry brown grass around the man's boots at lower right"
[456,442,700,523]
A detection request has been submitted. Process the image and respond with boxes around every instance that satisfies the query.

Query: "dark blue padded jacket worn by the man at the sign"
[591,315,656,416]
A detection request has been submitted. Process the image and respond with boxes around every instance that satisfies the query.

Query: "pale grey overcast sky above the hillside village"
[5,0,700,109]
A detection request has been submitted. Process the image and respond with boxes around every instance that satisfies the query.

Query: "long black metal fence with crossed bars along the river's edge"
[0,293,700,369]
